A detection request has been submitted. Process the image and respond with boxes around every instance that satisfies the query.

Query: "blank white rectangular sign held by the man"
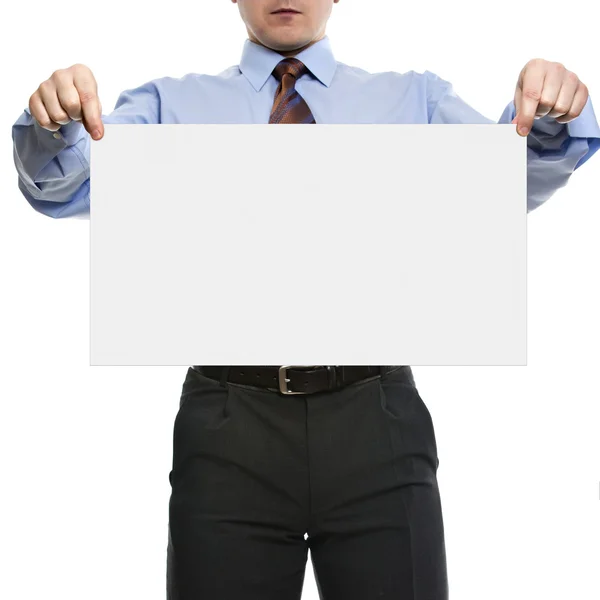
[90,124,527,366]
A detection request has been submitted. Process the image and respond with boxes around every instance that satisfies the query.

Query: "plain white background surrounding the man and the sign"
[0,0,600,600]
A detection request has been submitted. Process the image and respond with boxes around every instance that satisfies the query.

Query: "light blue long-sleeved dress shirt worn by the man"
[12,36,600,218]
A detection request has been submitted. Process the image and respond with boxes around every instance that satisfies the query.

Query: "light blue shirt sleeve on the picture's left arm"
[12,81,160,219]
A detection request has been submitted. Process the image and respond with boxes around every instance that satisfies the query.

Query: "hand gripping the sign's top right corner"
[512,58,589,136]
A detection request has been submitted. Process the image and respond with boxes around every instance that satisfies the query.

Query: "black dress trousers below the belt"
[167,367,448,600]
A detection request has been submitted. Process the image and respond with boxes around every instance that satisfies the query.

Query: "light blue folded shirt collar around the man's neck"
[240,36,337,92]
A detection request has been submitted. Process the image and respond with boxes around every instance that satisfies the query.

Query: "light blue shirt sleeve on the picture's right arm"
[424,71,600,212]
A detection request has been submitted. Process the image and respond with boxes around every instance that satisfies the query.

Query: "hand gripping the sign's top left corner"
[29,64,104,140]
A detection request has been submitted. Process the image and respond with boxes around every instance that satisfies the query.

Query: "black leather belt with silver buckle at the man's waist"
[192,366,414,394]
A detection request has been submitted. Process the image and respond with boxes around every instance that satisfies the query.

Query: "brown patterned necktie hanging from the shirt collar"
[269,58,315,125]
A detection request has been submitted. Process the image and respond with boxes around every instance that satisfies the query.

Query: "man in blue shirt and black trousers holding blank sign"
[13,0,600,600]
